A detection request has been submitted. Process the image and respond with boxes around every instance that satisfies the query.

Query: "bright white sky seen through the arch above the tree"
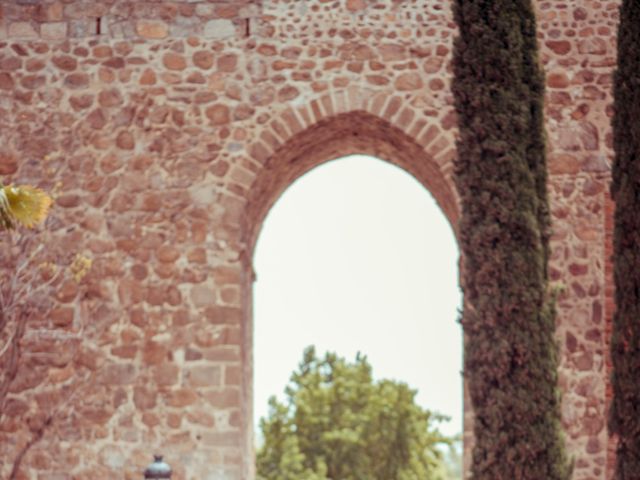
[254,155,462,434]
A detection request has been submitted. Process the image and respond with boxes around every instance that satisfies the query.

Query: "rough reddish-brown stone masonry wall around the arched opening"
[0,0,618,480]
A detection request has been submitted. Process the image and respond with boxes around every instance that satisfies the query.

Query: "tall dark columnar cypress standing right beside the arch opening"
[453,0,570,480]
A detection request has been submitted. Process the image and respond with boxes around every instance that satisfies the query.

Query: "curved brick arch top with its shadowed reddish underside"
[242,91,459,252]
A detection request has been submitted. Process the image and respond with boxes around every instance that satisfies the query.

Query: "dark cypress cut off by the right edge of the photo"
[609,0,640,480]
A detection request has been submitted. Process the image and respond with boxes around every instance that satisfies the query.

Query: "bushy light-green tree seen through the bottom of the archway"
[257,347,450,480]
